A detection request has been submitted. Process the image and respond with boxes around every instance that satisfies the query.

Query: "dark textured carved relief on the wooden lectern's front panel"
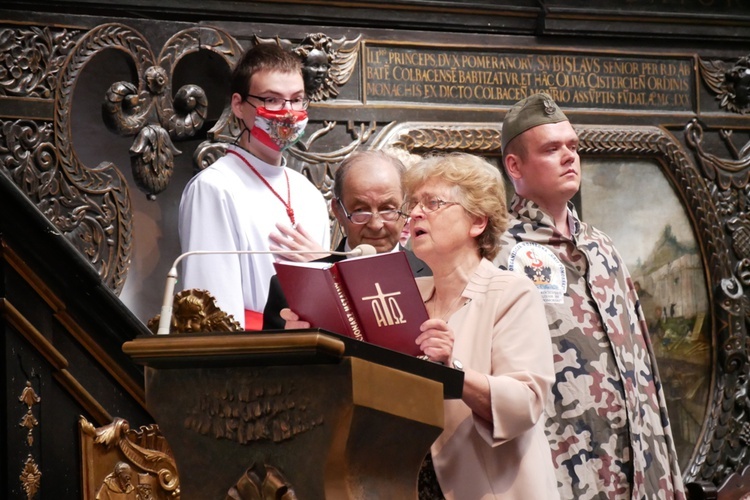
[184,377,323,444]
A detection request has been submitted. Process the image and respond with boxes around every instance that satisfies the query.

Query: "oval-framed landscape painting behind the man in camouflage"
[580,160,711,468]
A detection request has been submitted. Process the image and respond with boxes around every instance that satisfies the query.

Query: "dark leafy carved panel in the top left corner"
[0,26,80,99]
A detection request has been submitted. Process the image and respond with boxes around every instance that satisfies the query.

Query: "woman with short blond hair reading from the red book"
[281,153,558,500]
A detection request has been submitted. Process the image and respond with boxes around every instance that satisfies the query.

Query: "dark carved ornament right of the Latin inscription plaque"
[698,56,750,114]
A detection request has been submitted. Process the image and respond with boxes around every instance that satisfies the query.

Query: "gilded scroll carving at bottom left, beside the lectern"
[79,417,180,500]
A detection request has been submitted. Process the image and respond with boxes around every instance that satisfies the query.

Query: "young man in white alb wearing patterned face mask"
[179,44,330,330]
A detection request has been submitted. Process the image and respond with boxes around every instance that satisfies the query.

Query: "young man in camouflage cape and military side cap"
[496,94,685,500]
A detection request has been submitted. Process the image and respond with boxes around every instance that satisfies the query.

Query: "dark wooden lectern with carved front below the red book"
[123,330,463,500]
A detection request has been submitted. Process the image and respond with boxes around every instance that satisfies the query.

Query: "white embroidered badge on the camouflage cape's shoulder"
[508,241,568,304]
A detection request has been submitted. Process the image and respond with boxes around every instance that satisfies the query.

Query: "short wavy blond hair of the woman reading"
[402,153,508,260]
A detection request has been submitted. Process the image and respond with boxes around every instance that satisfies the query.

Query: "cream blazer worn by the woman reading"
[417,259,559,500]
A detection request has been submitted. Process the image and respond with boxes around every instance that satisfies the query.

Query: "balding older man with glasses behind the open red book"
[263,150,432,330]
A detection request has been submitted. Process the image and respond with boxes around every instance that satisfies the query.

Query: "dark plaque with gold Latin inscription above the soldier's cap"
[364,43,695,112]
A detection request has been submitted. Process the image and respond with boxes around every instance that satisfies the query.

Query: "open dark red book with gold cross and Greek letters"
[274,252,429,356]
